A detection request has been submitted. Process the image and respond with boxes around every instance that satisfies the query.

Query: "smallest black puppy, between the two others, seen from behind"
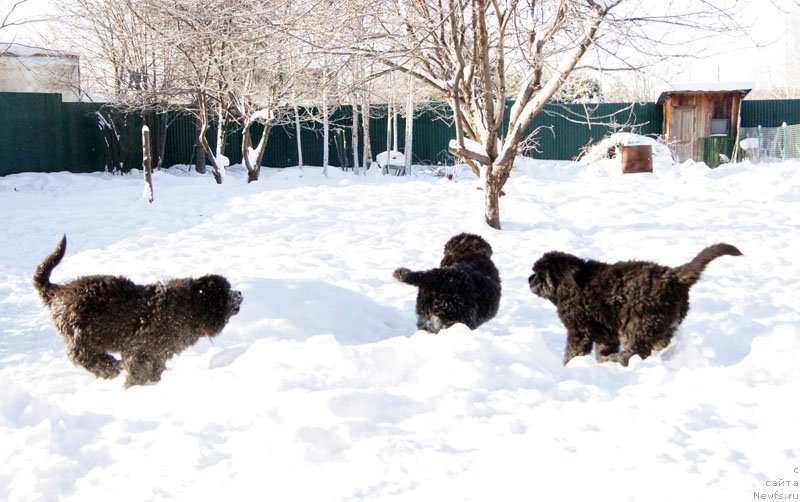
[393,233,500,333]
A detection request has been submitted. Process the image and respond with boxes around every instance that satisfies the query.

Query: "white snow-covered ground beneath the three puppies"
[0,155,800,502]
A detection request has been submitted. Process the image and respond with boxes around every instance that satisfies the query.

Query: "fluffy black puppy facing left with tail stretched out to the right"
[528,244,742,366]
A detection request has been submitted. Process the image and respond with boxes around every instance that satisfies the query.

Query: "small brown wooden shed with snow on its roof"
[657,82,753,167]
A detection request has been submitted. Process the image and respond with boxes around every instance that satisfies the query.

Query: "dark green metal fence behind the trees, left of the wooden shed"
[0,93,661,175]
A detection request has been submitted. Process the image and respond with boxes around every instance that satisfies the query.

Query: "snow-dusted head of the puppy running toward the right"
[190,275,243,336]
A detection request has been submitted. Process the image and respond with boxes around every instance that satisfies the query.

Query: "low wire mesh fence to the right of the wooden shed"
[739,122,800,162]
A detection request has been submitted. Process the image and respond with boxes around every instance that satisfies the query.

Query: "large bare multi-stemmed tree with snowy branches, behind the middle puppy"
[360,0,738,228]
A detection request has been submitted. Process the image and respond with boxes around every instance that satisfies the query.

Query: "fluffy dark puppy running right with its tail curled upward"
[33,236,242,387]
